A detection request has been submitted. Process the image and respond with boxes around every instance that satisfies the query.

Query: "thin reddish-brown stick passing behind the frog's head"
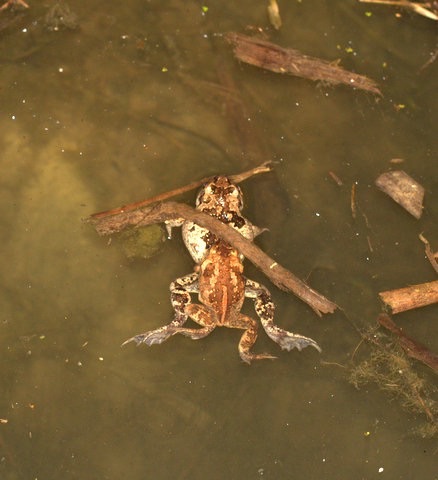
[91,162,273,220]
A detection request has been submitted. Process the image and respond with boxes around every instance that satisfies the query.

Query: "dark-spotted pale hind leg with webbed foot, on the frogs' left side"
[122,272,199,346]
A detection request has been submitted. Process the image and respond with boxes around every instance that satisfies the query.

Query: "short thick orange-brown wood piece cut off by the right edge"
[379,280,438,314]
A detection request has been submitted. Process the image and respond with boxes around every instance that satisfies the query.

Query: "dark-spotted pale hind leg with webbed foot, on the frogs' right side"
[245,279,321,352]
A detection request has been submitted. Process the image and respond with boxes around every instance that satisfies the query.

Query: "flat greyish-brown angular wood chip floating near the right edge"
[375,170,424,220]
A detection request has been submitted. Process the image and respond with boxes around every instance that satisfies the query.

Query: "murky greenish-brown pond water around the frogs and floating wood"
[0,0,438,480]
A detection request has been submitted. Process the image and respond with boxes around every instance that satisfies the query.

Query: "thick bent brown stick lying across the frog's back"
[89,202,337,316]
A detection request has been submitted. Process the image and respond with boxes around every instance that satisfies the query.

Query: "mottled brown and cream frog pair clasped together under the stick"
[123,175,321,364]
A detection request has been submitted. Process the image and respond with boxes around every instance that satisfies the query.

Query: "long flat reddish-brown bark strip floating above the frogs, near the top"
[226,32,381,95]
